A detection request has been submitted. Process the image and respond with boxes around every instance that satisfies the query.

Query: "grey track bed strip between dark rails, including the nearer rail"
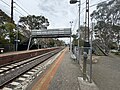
[0,48,62,87]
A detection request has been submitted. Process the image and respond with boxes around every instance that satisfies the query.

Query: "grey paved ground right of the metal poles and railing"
[93,54,120,90]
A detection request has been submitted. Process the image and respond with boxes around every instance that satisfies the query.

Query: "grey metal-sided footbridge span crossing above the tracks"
[31,28,71,38]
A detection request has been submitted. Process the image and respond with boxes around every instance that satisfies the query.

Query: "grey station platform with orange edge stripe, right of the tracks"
[31,48,82,90]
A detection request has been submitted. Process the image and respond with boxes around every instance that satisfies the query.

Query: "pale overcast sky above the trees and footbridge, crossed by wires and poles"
[0,0,105,41]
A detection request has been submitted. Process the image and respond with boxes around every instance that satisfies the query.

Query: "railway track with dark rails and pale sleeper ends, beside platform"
[0,48,62,90]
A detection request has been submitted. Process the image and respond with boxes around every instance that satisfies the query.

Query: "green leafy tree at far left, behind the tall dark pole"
[0,9,15,44]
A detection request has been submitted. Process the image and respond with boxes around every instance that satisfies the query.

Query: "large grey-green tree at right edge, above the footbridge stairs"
[91,0,120,48]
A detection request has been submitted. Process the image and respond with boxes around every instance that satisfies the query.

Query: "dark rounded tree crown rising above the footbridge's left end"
[19,15,49,30]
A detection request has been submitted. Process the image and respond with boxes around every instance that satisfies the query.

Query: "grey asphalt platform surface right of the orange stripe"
[48,50,82,90]
